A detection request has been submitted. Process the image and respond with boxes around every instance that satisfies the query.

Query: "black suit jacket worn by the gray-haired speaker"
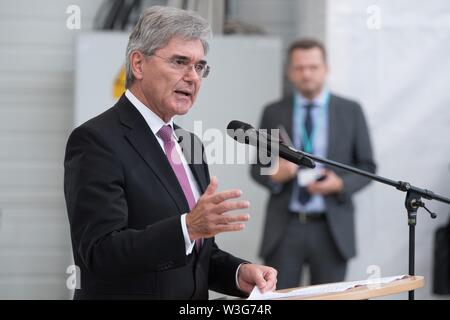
[64,95,243,299]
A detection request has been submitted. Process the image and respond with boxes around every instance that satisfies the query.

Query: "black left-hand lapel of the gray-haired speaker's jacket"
[117,95,189,213]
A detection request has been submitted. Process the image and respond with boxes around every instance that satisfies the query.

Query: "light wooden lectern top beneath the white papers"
[273,276,425,300]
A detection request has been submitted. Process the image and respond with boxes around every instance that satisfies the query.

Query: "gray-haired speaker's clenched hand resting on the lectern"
[238,263,277,294]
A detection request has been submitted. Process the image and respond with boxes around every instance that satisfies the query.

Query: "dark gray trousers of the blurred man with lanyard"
[266,214,347,289]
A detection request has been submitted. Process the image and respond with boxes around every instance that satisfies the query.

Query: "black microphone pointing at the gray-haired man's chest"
[227,120,316,168]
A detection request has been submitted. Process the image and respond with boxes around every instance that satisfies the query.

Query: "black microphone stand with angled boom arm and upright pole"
[288,149,450,300]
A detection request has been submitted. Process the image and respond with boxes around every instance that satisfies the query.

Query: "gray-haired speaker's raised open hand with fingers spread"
[186,177,250,241]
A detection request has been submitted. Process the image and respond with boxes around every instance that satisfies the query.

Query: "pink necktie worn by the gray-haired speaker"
[157,125,202,251]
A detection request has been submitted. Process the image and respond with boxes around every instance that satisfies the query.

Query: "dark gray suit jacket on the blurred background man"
[251,95,375,259]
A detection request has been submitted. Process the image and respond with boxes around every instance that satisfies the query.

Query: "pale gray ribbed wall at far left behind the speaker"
[0,0,100,299]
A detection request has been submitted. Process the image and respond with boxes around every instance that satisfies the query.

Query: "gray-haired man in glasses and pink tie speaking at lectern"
[64,7,277,299]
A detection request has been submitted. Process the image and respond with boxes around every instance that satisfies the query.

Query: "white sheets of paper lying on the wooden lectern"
[248,275,407,300]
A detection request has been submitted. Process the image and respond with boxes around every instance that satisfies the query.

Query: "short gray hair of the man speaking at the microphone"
[125,6,211,88]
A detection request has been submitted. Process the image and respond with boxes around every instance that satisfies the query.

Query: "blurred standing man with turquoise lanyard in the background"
[251,39,375,289]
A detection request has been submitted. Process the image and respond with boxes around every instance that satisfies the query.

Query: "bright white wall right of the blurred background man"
[327,0,450,299]
